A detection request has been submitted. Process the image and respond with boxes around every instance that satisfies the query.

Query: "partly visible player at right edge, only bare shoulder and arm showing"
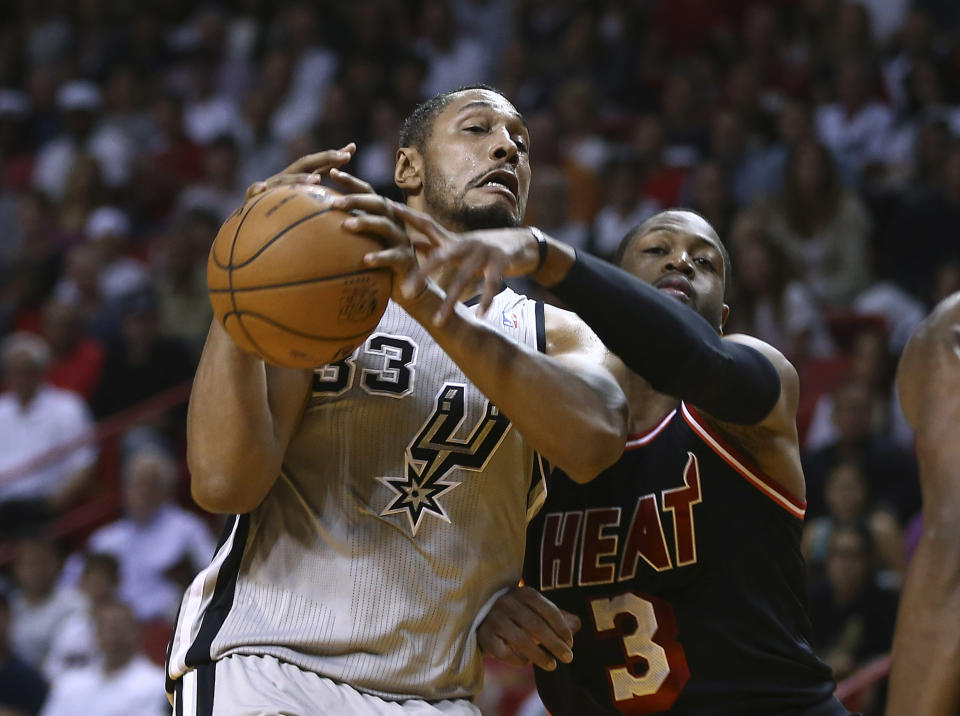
[887,293,960,716]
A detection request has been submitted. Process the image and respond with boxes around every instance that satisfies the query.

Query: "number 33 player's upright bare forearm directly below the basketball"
[187,321,308,513]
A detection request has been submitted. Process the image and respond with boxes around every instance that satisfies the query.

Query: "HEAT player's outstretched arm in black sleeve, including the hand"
[395,205,781,424]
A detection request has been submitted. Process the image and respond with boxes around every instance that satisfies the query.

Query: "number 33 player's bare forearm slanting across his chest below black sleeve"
[406,289,627,480]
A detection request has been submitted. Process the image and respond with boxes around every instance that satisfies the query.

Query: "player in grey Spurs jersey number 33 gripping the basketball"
[167,89,627,716]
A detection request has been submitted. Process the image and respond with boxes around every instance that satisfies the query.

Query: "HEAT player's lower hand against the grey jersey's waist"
[477,587,580,671]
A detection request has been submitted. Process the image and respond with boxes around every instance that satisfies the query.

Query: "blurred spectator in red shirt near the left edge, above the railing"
[41,298,104,400]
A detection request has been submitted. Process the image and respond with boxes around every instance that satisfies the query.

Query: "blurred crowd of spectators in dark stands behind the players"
[0,0,960,715]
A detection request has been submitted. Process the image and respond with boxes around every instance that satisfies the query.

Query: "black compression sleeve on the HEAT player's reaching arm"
[550,252,780,424]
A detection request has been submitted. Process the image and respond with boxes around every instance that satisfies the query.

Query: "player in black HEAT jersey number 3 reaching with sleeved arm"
[354,207,847,716]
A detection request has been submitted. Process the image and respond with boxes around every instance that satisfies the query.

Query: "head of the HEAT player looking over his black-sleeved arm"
[621,212,729,331]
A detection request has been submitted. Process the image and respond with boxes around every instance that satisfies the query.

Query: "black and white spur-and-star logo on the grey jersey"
[377,383,510,535]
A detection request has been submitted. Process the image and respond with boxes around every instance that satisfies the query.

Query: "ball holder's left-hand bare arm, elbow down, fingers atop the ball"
[187,147,371,514]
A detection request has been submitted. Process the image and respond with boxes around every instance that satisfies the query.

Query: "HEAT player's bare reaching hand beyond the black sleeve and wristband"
[394,204,540,325]
